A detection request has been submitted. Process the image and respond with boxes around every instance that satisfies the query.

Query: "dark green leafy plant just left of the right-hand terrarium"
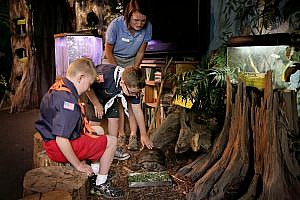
[168,49,226,117]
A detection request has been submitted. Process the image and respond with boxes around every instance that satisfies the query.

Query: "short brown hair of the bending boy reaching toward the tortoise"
[122,66,145,89]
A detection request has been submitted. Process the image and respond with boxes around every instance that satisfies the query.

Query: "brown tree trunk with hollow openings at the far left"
[9,0,38,112]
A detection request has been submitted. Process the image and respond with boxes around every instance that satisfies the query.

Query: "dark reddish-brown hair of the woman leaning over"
[124,0,149,27]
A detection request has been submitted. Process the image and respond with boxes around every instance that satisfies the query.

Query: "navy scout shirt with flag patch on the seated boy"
[35,78,82,141]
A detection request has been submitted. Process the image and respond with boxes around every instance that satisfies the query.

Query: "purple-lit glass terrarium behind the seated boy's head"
[54,33,103,77]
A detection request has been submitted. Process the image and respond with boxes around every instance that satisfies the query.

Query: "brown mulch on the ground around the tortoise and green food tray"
[89,146,196,200]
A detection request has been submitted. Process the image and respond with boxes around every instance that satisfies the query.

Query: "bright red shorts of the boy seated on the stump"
[43,134,107,163]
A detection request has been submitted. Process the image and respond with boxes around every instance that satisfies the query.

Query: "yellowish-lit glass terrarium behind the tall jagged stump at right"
[227,34,300,90]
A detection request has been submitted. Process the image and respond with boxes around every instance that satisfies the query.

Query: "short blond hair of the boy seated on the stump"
[67,58,97,79]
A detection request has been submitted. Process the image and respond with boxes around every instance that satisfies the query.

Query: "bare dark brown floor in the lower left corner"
[0,110,38,200]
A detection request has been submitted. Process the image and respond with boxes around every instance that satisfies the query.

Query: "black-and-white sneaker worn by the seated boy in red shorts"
[90,181,124,198]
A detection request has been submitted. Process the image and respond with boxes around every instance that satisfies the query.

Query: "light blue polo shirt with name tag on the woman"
[106,16,152,58]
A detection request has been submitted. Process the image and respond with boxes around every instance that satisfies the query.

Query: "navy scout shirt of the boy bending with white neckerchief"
[91,64,140,106]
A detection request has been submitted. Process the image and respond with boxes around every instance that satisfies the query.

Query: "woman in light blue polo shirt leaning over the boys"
[105,0,152,150]
